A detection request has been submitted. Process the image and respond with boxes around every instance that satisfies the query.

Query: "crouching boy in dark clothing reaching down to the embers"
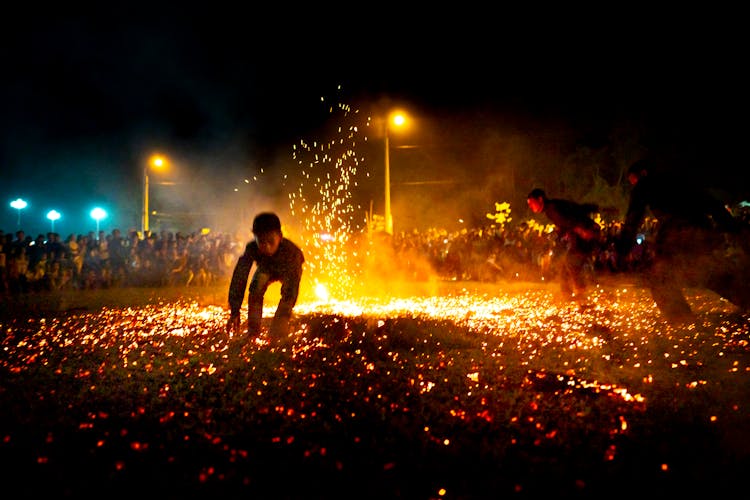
[227,212,305,340]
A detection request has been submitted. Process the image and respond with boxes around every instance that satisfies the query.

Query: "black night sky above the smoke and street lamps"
[0,2,750,236]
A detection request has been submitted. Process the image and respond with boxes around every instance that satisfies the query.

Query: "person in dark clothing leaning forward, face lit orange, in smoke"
[526,188,601,302]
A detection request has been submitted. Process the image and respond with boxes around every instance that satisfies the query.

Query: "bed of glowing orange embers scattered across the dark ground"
[0,284,750,496]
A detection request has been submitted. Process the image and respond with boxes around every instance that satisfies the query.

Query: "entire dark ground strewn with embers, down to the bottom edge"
[0,284,750,499]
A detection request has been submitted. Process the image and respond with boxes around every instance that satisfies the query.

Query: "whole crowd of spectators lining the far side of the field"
[0,208,748,294]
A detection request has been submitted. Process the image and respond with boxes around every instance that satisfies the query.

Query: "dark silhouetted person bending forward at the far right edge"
[617,160,750,321]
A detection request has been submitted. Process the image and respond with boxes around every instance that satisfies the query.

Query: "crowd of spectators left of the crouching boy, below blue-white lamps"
[0,229,244,294]
